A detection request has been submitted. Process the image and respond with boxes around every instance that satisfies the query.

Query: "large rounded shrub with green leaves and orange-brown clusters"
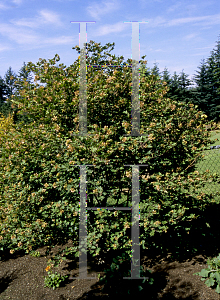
[0,41,218,255]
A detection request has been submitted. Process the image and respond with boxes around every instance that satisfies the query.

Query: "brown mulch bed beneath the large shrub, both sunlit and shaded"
[0,205,220,300]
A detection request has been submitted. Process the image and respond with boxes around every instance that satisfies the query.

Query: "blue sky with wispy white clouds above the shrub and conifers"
[0,0,220,86]
